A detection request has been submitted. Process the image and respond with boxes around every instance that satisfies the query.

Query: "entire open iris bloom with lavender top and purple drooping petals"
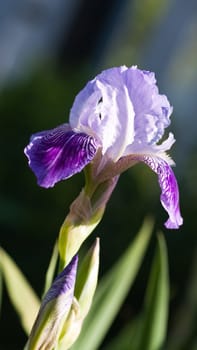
[25,66,183,229]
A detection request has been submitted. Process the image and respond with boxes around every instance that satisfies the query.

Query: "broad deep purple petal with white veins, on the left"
[25,124,97,188]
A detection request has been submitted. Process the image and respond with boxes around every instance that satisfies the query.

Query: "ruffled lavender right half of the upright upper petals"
[124,67,172,145]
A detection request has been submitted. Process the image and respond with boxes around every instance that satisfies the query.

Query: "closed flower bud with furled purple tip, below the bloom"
[25,256,78,350]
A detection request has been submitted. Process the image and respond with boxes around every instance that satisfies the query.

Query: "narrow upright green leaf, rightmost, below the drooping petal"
[137,234,169,350]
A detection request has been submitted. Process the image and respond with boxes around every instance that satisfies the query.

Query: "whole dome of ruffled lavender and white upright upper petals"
[70,66,172,162]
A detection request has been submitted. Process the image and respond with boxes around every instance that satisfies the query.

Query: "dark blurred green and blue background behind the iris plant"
[0,0,197,350]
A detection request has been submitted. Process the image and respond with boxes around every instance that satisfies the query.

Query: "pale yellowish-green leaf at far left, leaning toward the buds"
[0,248,40,334]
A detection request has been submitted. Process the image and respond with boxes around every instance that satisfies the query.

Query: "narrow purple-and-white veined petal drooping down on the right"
[138,156,183,229]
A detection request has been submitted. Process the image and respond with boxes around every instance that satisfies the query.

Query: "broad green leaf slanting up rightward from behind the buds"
[72,220,153,350]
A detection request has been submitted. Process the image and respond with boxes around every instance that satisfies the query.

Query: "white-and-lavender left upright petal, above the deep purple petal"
[70,67,134,162]
